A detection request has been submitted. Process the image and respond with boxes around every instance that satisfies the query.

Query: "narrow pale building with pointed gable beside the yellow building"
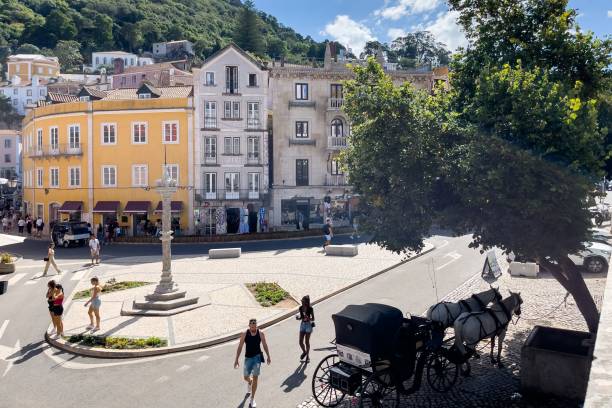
[193,45,269,235]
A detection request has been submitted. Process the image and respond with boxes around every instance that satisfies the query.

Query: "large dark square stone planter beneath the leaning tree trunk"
[521,326,593,400]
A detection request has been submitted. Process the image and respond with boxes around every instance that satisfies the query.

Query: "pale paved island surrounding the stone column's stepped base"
[51,244,433,357]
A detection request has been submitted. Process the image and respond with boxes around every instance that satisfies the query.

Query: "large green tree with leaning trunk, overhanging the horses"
[345,0,611,332]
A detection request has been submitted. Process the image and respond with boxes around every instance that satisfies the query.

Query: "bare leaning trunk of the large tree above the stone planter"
[540,257,599,333]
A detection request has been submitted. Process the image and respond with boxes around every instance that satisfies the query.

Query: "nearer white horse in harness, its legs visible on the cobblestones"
[454,292,523,368]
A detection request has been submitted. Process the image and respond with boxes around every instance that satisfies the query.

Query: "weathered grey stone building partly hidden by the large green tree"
[269,44,434,229]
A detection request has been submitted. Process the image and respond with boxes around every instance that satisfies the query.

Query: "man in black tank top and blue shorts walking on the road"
[234,319,272,408]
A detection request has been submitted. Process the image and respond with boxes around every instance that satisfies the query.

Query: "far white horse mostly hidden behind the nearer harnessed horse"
[427,286,502,329]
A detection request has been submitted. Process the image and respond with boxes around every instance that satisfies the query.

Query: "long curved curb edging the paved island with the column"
[44,244,436,359]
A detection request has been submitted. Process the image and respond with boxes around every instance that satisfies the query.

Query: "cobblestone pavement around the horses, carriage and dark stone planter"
[298,260,606,408]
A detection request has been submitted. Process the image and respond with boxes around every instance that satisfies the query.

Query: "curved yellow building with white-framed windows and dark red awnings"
[22,83,193,236]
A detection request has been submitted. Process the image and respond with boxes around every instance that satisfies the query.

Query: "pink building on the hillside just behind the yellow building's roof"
[112,60,193,89]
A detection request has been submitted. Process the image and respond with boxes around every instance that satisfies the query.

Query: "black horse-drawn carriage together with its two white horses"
[312,289,522,407]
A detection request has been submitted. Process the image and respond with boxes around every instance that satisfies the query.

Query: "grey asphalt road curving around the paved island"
[0,231,484,408]
